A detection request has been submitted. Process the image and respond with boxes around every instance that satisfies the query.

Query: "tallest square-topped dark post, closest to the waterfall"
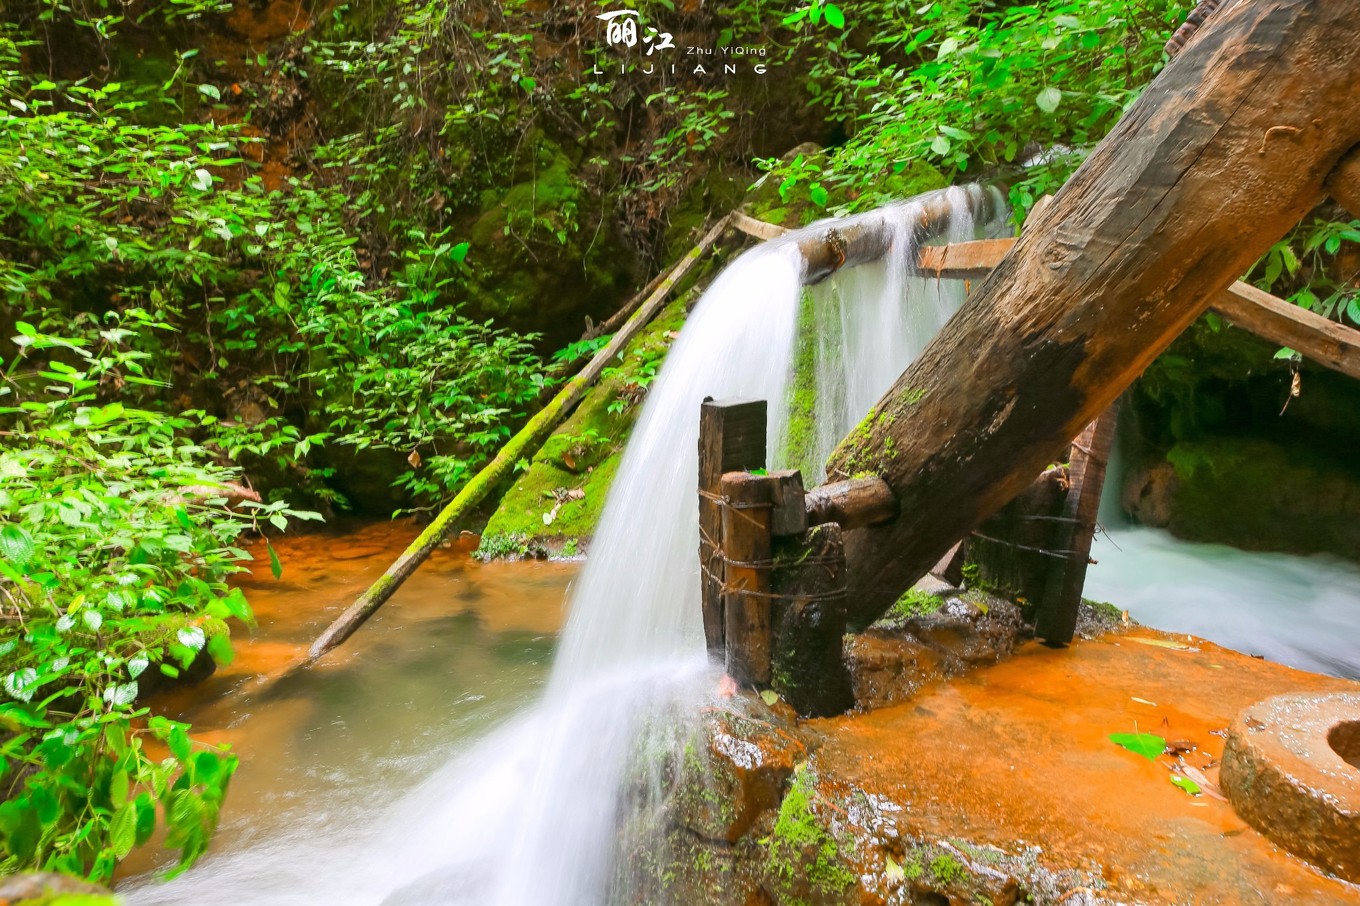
[699,399,767,657]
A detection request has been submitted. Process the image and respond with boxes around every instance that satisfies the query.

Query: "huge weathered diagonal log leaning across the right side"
[827,0,1360,622]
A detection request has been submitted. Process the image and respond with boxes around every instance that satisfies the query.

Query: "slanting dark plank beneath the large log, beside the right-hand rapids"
[1035,403,1119,646]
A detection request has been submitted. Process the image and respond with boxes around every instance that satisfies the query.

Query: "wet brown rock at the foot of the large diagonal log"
[846,592,1028,710]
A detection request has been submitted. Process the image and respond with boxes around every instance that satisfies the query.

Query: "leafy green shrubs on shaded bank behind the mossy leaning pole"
[0,15,547,503]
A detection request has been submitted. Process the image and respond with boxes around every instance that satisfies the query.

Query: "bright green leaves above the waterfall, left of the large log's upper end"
[764,0,1193,216]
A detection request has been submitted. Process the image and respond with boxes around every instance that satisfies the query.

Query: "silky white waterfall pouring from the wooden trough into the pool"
[126,188,1000,906]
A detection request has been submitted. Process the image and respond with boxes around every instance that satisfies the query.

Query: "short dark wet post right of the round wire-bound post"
[770,522,854,717]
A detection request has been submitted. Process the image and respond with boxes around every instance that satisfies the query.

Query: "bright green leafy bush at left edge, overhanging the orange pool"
[0,322,316,880]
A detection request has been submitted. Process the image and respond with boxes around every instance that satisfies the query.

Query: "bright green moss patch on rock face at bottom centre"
[766,767,854,902]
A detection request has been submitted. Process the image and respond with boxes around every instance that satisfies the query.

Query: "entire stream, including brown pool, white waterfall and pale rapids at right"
[120,189,1360,906]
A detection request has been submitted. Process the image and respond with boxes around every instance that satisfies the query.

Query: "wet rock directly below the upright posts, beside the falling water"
[673,711,806,843]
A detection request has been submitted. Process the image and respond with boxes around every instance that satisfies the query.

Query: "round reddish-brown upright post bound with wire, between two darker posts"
[721,472,775,686]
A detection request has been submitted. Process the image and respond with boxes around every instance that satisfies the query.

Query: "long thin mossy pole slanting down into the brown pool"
[307,218,726,661]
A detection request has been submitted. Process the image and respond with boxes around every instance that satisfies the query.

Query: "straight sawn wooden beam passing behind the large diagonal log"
[921,239,1360,378]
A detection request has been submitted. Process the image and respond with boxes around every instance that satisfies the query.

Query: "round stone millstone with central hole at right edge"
[1220,692,1360,883]
